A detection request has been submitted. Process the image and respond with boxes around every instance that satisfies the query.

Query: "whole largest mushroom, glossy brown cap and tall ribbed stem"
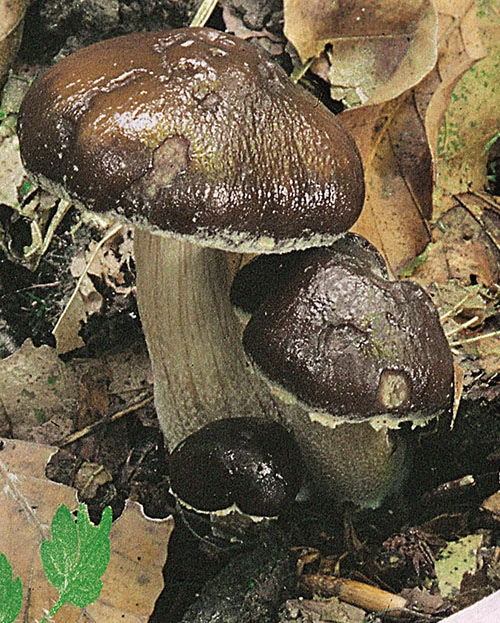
[18,28,364,448]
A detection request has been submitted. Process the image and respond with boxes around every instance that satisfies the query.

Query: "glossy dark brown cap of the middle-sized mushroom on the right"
[243,236,453,425]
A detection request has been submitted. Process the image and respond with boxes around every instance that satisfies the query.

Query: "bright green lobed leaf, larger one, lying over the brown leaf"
[41,504,112,609]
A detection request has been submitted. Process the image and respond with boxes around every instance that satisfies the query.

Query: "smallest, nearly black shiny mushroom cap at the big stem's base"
[169,417,303,517]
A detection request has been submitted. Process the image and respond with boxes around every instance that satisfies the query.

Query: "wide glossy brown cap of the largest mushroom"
[18,28,364,252]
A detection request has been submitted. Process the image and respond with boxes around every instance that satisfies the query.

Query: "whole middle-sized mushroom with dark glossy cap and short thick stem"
[239,234,453,506]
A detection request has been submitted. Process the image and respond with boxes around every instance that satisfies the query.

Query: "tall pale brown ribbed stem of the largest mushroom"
[134,229,279,449]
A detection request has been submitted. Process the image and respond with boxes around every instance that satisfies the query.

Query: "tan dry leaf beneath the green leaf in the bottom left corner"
[0,440,173,623]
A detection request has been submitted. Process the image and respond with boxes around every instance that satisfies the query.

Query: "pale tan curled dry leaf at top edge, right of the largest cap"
[284,0,438,106]
